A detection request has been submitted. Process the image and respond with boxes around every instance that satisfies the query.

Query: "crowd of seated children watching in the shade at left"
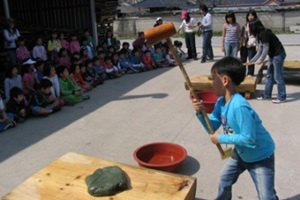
[0,28,190,131]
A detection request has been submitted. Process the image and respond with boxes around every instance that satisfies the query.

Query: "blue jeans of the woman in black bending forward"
[263,52,286,100]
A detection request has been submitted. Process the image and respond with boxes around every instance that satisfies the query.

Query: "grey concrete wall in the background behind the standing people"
[114,10,300,38]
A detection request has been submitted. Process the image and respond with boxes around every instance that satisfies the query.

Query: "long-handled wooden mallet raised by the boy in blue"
[144,22,232,159]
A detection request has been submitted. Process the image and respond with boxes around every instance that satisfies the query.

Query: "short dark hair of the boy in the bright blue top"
[211,56,246,86]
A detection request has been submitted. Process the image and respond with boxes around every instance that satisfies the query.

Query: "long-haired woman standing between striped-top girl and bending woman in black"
[240,9,258,76]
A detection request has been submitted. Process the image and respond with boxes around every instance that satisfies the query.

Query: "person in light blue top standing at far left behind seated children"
[3,18,20,65]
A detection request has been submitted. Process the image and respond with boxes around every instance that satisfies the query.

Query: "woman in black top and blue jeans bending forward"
[249,20,286,104]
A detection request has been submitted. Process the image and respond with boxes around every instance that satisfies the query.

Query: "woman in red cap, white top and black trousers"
[177,11,198,60]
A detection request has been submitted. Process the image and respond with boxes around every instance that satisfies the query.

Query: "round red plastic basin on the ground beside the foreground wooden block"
[133,142,187,172]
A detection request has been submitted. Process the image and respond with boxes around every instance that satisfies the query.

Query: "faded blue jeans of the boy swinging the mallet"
[216,152,278,200]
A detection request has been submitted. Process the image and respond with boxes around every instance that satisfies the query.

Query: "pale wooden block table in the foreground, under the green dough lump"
[2,153,196,200]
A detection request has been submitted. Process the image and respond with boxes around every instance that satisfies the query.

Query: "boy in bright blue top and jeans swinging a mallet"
[193,57,278,200]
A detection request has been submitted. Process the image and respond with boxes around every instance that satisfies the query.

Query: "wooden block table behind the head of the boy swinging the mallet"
[185,75,256,99]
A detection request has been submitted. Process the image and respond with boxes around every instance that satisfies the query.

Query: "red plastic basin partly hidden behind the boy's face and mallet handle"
[192,90,219,113]
